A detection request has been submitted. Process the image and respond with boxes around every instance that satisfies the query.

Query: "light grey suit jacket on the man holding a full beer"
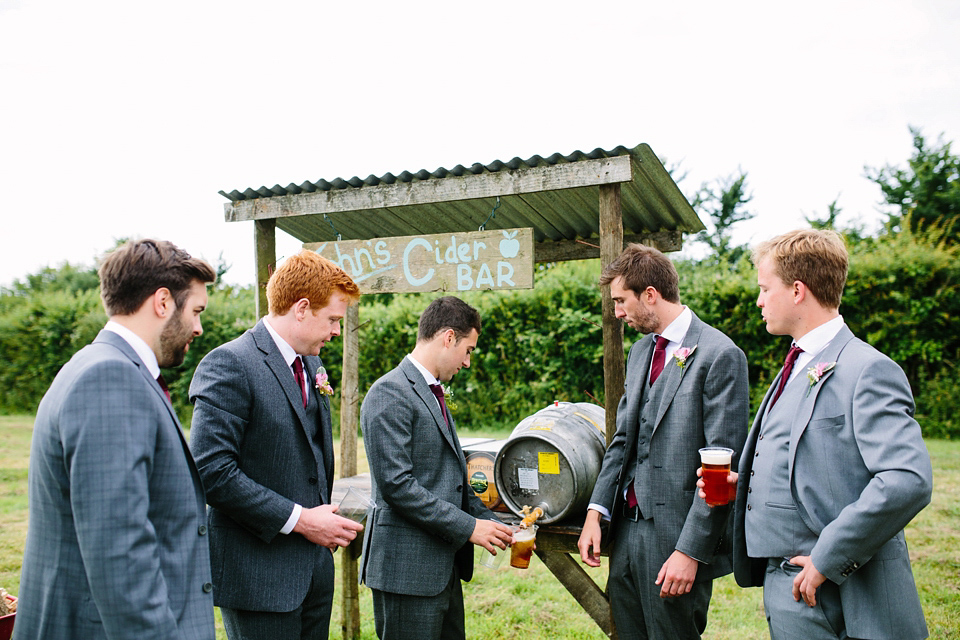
[734,327,933,640]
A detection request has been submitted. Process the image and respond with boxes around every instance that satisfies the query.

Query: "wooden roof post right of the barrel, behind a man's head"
[600,184,624,444]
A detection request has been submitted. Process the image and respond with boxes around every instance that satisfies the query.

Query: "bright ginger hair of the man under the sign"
[267,249,360,316]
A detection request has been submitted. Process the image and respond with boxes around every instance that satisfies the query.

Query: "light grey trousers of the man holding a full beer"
[763,558,849,640]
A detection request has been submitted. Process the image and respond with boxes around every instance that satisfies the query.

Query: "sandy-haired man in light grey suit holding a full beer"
[730,230,933,640]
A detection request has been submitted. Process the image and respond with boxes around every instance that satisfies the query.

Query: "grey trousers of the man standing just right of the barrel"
[607,518,713,640]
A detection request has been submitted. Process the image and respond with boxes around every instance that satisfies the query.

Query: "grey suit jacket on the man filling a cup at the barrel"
[360,358,497,596]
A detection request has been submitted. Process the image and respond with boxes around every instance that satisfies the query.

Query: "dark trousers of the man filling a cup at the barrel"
[370,569,466,640]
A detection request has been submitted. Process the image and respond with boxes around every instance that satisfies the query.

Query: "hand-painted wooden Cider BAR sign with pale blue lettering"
[303,229,533,293]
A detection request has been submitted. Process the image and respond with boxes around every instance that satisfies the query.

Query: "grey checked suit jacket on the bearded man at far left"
[13,331,214,640]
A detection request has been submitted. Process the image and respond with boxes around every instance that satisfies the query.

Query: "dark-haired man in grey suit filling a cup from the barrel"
[360,296,512,640]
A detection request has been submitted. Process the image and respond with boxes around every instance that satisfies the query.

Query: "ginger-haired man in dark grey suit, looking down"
[190,251,363,640]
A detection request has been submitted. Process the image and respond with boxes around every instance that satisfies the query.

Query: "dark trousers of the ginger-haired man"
[220,550,334,640]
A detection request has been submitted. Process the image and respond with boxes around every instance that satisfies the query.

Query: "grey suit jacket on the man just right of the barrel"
[590,314,749,580]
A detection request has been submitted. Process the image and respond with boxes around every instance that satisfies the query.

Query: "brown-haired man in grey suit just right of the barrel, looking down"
[578,244,749,640]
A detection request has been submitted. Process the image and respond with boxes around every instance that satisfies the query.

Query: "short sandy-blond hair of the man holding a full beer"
[753,229,848,309]
